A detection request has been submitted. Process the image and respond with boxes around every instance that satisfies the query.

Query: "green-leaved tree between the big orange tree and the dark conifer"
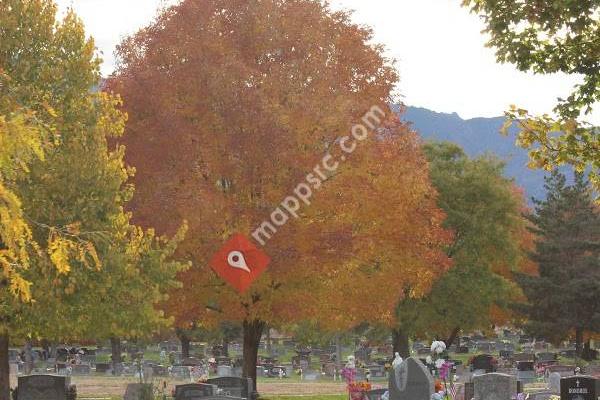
[393,143,524,356]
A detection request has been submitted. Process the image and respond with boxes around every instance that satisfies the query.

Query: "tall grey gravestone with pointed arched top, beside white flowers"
[389,357,434,400]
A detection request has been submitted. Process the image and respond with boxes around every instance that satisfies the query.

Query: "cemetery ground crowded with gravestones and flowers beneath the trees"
[11,330,600,400]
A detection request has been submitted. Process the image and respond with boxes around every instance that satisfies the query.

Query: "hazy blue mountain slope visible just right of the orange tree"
[401,107,560,200]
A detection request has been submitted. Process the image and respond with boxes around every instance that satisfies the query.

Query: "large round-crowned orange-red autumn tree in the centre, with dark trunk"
[108,0,450,388]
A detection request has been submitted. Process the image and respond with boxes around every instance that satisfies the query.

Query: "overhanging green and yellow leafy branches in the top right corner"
[463,0,600,191]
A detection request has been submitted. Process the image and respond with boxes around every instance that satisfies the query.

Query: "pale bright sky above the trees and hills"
[56,0,600,125]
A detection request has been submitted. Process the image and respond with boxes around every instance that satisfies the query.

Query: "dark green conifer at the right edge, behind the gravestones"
[517,172,600,354]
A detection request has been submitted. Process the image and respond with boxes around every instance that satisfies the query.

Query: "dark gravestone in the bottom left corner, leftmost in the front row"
[17,375,71,400]
